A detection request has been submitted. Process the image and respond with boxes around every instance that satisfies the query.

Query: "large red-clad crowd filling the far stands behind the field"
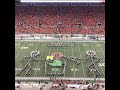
[15,6,105,34]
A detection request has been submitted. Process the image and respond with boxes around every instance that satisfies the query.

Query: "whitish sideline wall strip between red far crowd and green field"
[15,34,105,41]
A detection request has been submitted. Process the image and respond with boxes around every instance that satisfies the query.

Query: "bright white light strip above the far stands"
[21,0,105,3]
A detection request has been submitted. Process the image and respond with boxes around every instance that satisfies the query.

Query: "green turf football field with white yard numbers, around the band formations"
[15,40,105,78]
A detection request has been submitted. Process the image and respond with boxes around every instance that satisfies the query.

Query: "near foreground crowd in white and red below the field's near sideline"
[16,79,105,90]
